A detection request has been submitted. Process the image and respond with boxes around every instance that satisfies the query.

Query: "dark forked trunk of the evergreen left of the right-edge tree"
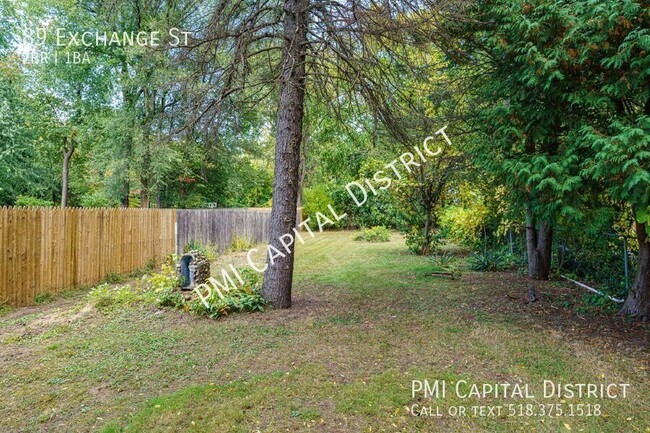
[526,211,553,280]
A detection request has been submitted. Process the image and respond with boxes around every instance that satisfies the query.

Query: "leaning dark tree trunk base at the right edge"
[620,222,650,322]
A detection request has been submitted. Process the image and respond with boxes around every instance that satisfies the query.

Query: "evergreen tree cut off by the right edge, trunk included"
[567,0,650,320]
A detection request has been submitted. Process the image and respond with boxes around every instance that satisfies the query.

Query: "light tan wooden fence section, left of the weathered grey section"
[0,207,176,306]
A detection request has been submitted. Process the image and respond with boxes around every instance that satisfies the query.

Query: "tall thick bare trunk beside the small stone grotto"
[262,0,309,308]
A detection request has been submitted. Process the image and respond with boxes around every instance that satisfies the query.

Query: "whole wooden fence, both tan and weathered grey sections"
[0,207,301,306]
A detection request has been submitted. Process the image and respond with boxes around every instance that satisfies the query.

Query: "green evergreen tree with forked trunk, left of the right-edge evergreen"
[454,0,585,279]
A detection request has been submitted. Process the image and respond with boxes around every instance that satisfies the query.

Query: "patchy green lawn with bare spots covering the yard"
[0,232,650,432]
